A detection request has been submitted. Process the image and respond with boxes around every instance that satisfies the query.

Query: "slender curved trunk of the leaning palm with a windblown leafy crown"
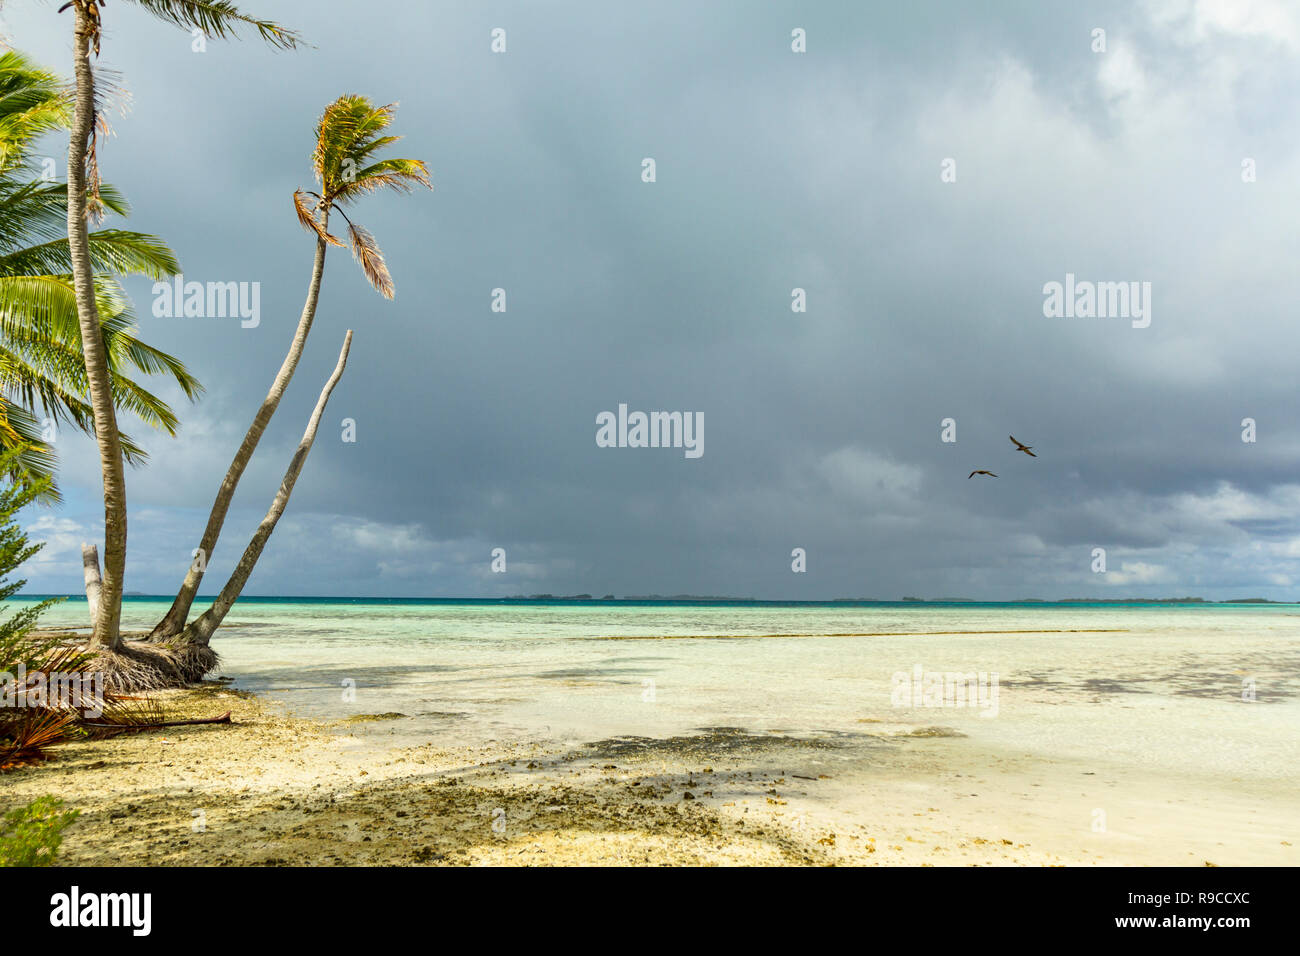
[150,230,329,641]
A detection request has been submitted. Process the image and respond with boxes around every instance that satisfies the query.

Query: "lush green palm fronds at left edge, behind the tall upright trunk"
[0,51,202,501]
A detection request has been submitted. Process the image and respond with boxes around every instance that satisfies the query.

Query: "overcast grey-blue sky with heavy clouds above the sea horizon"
[0,0,1300,600]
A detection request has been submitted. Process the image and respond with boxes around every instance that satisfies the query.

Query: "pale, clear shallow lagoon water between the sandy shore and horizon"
[17,600,1300,786]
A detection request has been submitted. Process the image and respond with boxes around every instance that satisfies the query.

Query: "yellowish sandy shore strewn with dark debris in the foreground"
[0,682,1296,866]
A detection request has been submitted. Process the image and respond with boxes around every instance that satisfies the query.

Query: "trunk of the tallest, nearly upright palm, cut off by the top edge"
[68,3,126,650]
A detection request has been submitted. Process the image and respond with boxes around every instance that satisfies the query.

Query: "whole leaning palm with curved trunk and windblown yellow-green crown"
[151,95,432,641]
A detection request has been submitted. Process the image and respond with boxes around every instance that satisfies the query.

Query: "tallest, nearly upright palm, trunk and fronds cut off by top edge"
[60,0,299,646]
